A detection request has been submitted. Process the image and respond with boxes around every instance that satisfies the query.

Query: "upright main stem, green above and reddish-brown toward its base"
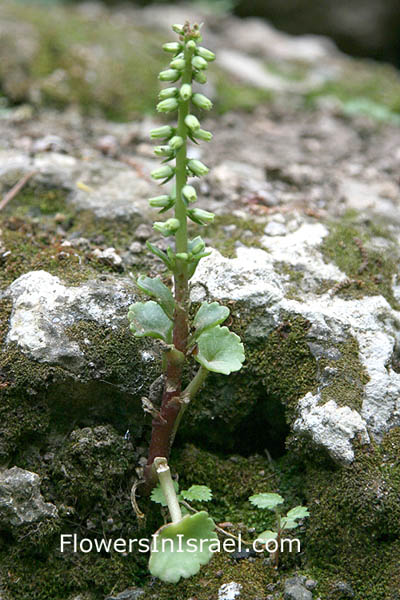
[144,42,193,493]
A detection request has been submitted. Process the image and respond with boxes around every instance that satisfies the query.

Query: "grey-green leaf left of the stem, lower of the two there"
[128,300,173,344]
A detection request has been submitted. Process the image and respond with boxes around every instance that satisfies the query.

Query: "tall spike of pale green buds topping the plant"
[148,23,215,272]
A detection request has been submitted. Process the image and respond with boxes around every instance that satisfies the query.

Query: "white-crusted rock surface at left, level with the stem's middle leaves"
[5,271,134,369]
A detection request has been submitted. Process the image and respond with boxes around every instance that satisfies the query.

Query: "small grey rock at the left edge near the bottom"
[0,467,57,527]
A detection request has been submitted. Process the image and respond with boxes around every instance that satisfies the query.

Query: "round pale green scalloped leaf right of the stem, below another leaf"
[195,325,245,375]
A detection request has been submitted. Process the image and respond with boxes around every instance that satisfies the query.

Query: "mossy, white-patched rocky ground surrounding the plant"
[0,4,400,600]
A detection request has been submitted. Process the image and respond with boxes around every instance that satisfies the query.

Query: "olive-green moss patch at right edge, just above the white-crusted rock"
[321,213,399,310]
